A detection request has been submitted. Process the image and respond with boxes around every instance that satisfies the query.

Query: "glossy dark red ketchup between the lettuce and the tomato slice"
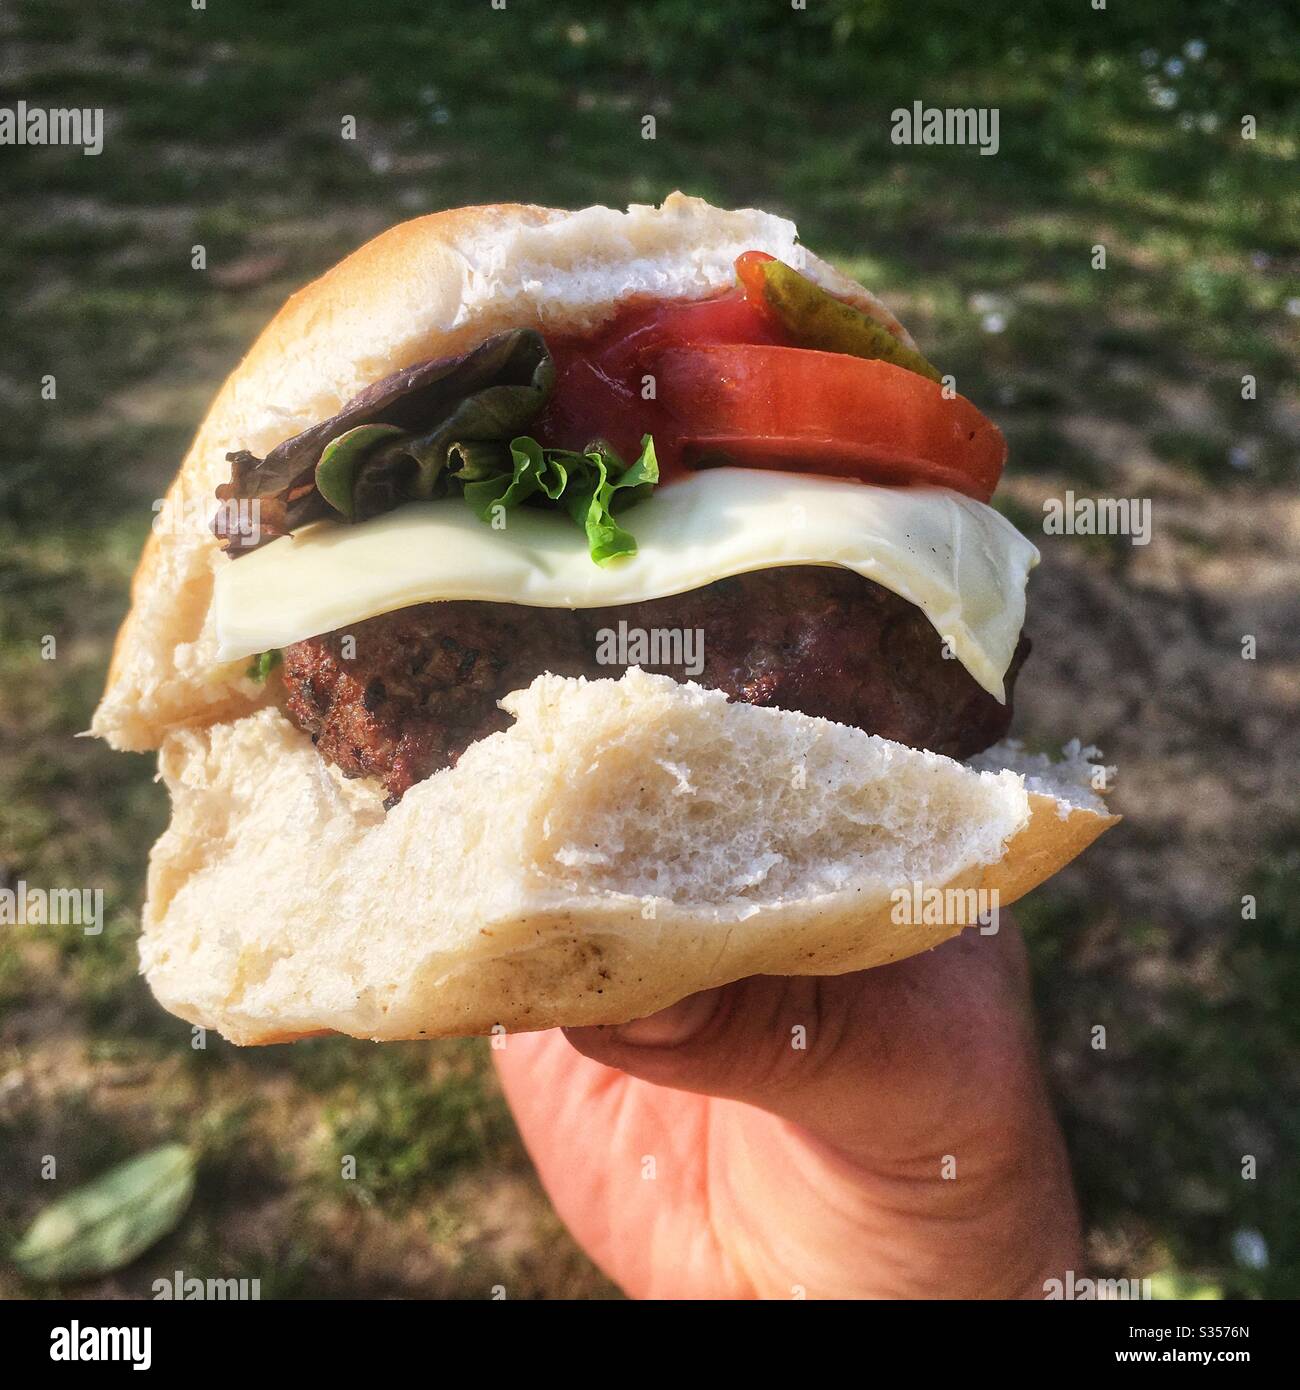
[534,252,791,482]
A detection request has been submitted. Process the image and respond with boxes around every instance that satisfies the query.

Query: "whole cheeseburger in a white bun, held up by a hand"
[93,193,1115,1043]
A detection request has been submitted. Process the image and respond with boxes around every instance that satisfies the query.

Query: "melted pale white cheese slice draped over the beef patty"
[213,468,1039,701]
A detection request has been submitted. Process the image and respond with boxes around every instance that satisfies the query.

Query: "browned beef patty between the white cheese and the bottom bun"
[284,566,1029,805]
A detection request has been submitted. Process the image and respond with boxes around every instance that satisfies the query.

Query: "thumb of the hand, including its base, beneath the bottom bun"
[564,933,1041,1169]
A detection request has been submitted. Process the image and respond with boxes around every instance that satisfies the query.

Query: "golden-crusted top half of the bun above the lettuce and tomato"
[92,193,911,751]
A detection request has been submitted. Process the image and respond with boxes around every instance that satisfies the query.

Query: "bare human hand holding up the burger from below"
[494,913,1079,1298]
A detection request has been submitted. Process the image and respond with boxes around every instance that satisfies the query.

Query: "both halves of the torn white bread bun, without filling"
[92,193,1115,1043]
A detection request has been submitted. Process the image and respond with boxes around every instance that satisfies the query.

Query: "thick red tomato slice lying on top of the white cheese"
[656,343,1007,502]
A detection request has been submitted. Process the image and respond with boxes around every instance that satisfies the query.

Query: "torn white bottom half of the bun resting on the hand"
[140,670,1116,1043]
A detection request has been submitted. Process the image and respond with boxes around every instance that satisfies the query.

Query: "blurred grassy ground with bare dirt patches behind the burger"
[0,0,1300,1297]
